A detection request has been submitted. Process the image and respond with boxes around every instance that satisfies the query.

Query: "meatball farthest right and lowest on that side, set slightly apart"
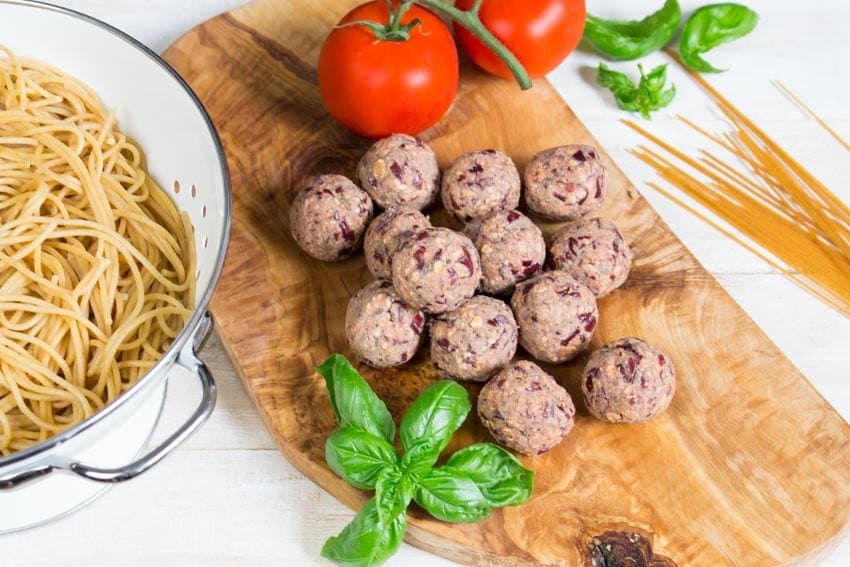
[581,337,676,423]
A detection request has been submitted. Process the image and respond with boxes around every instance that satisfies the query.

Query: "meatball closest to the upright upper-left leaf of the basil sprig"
[345,280,425,368]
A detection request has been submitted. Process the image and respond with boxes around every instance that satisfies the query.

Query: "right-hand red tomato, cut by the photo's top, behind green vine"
[454,0,586,77]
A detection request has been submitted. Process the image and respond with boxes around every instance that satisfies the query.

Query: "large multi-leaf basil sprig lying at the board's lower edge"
[316,354,534,567]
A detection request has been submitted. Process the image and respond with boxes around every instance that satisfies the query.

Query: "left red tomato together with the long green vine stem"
[318,0,540,138]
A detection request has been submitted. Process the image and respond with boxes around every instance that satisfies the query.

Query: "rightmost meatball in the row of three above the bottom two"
[511,270,599,362]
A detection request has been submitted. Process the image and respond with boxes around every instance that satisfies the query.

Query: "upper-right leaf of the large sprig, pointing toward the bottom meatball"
[399,380,472,460]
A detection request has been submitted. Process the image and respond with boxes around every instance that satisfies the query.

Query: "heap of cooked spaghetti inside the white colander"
[0,46,195,456]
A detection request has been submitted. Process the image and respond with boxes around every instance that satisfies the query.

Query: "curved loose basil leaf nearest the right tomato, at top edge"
[584,0,682,61]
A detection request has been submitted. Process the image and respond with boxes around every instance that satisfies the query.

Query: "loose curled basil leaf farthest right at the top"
[679,3,758,73]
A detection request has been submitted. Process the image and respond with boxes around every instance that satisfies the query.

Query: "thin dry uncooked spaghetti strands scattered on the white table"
[625,63,850,317]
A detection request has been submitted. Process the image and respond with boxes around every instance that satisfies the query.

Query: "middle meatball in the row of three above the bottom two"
[431,295,517,382]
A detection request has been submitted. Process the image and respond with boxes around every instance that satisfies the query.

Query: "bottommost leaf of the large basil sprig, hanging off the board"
[322,498,407,567]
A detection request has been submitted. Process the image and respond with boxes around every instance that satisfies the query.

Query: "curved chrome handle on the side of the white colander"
[0,313,216,490]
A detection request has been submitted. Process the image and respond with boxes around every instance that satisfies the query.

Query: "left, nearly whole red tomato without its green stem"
[319,0,458,138]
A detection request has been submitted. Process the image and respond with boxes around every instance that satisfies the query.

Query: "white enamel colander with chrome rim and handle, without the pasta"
[0,0,230,533]
